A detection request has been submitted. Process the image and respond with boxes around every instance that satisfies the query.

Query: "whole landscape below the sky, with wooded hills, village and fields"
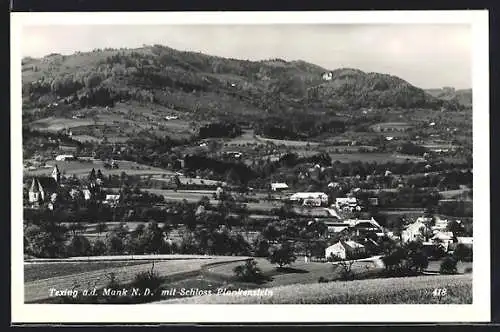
[18,34,474,304]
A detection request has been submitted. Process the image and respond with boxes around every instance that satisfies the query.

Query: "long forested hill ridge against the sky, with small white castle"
[22,45,457,114]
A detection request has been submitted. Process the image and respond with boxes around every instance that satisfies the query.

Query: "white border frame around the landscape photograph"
[11,10,490,323]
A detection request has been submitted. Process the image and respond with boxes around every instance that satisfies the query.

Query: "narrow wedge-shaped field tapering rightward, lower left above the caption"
[24,261,153,282]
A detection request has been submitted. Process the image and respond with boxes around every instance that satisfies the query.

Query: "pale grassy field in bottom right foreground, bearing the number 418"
[159,275,472,304]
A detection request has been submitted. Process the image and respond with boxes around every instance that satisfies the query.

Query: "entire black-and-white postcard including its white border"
[11,11,490,323]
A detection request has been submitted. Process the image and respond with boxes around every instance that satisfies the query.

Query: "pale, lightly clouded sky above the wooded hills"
[21,24,472,89]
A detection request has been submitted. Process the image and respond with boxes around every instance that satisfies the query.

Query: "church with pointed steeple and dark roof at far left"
[28,165,61,207]
